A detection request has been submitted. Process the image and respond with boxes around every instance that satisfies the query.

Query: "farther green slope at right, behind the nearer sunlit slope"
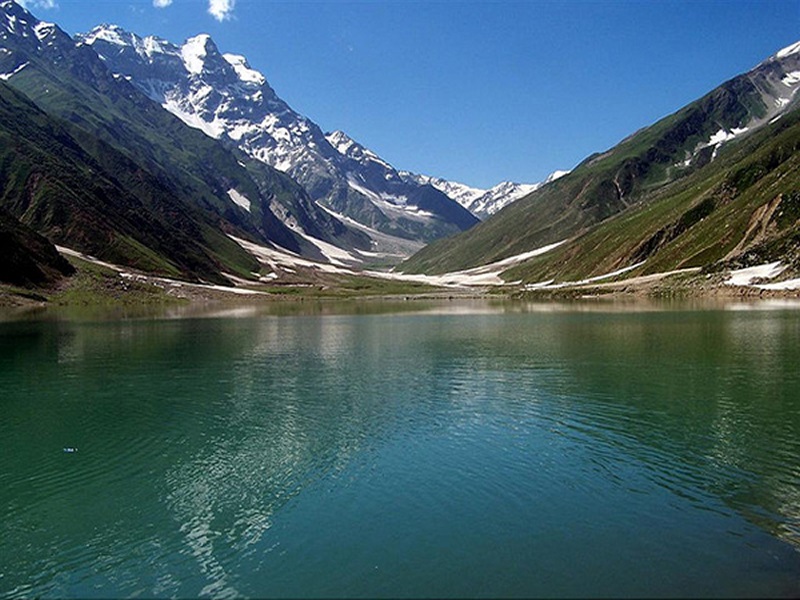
[401,71,788,273]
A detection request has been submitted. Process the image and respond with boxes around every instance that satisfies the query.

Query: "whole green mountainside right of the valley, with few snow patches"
[399,42,800,283]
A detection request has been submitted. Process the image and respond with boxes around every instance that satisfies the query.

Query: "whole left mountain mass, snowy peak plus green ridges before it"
[0,0,536,282]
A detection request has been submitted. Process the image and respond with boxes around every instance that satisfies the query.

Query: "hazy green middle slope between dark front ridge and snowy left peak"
[10,57,274,278]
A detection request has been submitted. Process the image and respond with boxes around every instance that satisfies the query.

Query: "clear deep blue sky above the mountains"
[15,0,800,187]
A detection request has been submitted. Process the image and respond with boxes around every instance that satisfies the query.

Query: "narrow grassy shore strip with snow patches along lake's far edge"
[0,255,800,310]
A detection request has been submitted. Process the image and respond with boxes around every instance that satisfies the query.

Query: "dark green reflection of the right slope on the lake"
[540,311,800,546]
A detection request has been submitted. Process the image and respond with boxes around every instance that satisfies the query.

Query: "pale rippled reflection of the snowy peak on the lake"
[166,317,406,597]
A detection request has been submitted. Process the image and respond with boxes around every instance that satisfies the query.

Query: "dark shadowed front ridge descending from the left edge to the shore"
[0,80,255,281]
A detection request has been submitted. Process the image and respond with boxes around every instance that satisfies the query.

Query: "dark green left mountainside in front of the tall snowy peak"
[0,0,372,279]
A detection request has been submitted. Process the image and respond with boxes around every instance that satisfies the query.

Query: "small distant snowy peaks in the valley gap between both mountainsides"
[400,171,569,220]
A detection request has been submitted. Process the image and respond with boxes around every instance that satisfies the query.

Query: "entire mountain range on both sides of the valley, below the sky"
[0,0,800,296]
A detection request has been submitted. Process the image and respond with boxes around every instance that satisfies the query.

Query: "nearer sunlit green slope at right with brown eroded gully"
[504,111,800,282]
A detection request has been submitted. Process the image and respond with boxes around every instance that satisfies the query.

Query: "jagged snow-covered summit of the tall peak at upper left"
[77,25,335,171]
